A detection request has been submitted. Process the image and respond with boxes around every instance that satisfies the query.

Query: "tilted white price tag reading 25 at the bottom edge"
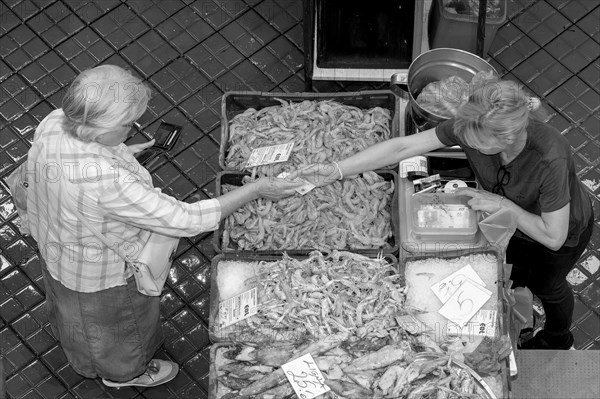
[281,353,330,399]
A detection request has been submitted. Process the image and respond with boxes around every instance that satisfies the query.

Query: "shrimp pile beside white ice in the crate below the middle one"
[211,251,405,343]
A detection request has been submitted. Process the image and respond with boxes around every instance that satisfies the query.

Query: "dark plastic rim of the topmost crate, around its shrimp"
[219,90,400,170]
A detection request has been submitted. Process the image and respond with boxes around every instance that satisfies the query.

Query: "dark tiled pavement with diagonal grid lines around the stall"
[0,0,600,399]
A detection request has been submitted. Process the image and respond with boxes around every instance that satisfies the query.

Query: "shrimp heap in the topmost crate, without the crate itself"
[225,99,391,176]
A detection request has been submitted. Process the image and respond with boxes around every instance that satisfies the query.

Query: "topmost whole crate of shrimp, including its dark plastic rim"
[219,90,400,176]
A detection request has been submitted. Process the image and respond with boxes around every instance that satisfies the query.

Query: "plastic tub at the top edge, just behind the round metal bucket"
[428,0,506,58]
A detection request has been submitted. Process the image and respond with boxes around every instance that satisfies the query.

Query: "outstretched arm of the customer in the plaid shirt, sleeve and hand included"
[98,178,303,237]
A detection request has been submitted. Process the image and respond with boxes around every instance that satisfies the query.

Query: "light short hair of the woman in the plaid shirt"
[62,65,151,141]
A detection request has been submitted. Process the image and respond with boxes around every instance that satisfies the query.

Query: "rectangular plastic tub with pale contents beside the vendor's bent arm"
[410,193,478,241]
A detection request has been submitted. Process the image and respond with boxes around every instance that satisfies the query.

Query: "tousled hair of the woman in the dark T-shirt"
[454,80,546,148]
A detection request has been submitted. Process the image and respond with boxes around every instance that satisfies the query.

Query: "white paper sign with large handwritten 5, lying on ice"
[439,280,492,326]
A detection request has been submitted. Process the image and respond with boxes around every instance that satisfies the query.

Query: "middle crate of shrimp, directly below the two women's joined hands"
[213,169,399,255]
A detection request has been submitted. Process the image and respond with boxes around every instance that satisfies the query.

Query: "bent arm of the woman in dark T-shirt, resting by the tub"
[456,188,570,251]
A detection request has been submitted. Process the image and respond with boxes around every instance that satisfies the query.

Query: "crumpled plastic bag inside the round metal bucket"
[417,71,498,118]
